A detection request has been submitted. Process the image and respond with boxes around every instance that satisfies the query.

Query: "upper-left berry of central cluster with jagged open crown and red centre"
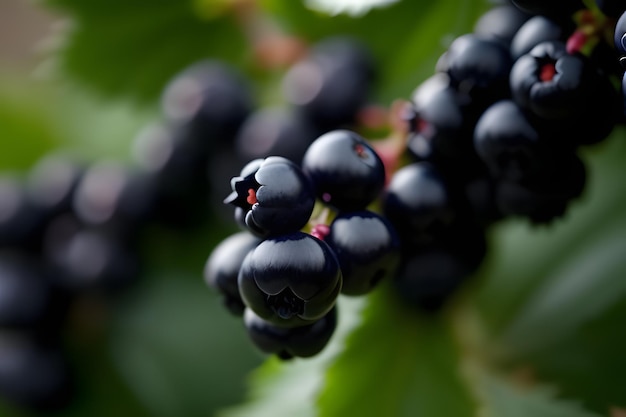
[224,156,315,238]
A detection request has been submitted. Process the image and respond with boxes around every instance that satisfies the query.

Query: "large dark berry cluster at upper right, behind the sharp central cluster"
[390,0,623,308]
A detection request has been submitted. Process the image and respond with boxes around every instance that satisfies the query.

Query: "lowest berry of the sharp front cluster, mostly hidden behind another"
[244,306,337,359]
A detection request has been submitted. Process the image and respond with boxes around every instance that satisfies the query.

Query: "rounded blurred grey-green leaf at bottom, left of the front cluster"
[108,266,261,417]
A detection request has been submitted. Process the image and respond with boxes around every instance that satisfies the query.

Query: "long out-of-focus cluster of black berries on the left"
[0,56,260,412]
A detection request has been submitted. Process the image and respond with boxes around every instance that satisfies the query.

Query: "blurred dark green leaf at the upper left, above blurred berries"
[41,0,245,103]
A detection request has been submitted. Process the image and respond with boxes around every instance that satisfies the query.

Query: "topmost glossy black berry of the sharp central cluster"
[302,130,385,211]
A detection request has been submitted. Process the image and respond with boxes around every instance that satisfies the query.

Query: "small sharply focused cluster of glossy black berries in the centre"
[205,129,399,359]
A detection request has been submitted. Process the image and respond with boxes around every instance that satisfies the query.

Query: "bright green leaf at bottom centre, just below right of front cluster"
[318,288,474,417]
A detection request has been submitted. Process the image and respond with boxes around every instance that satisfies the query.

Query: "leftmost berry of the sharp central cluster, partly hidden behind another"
[204,232,261,316]
